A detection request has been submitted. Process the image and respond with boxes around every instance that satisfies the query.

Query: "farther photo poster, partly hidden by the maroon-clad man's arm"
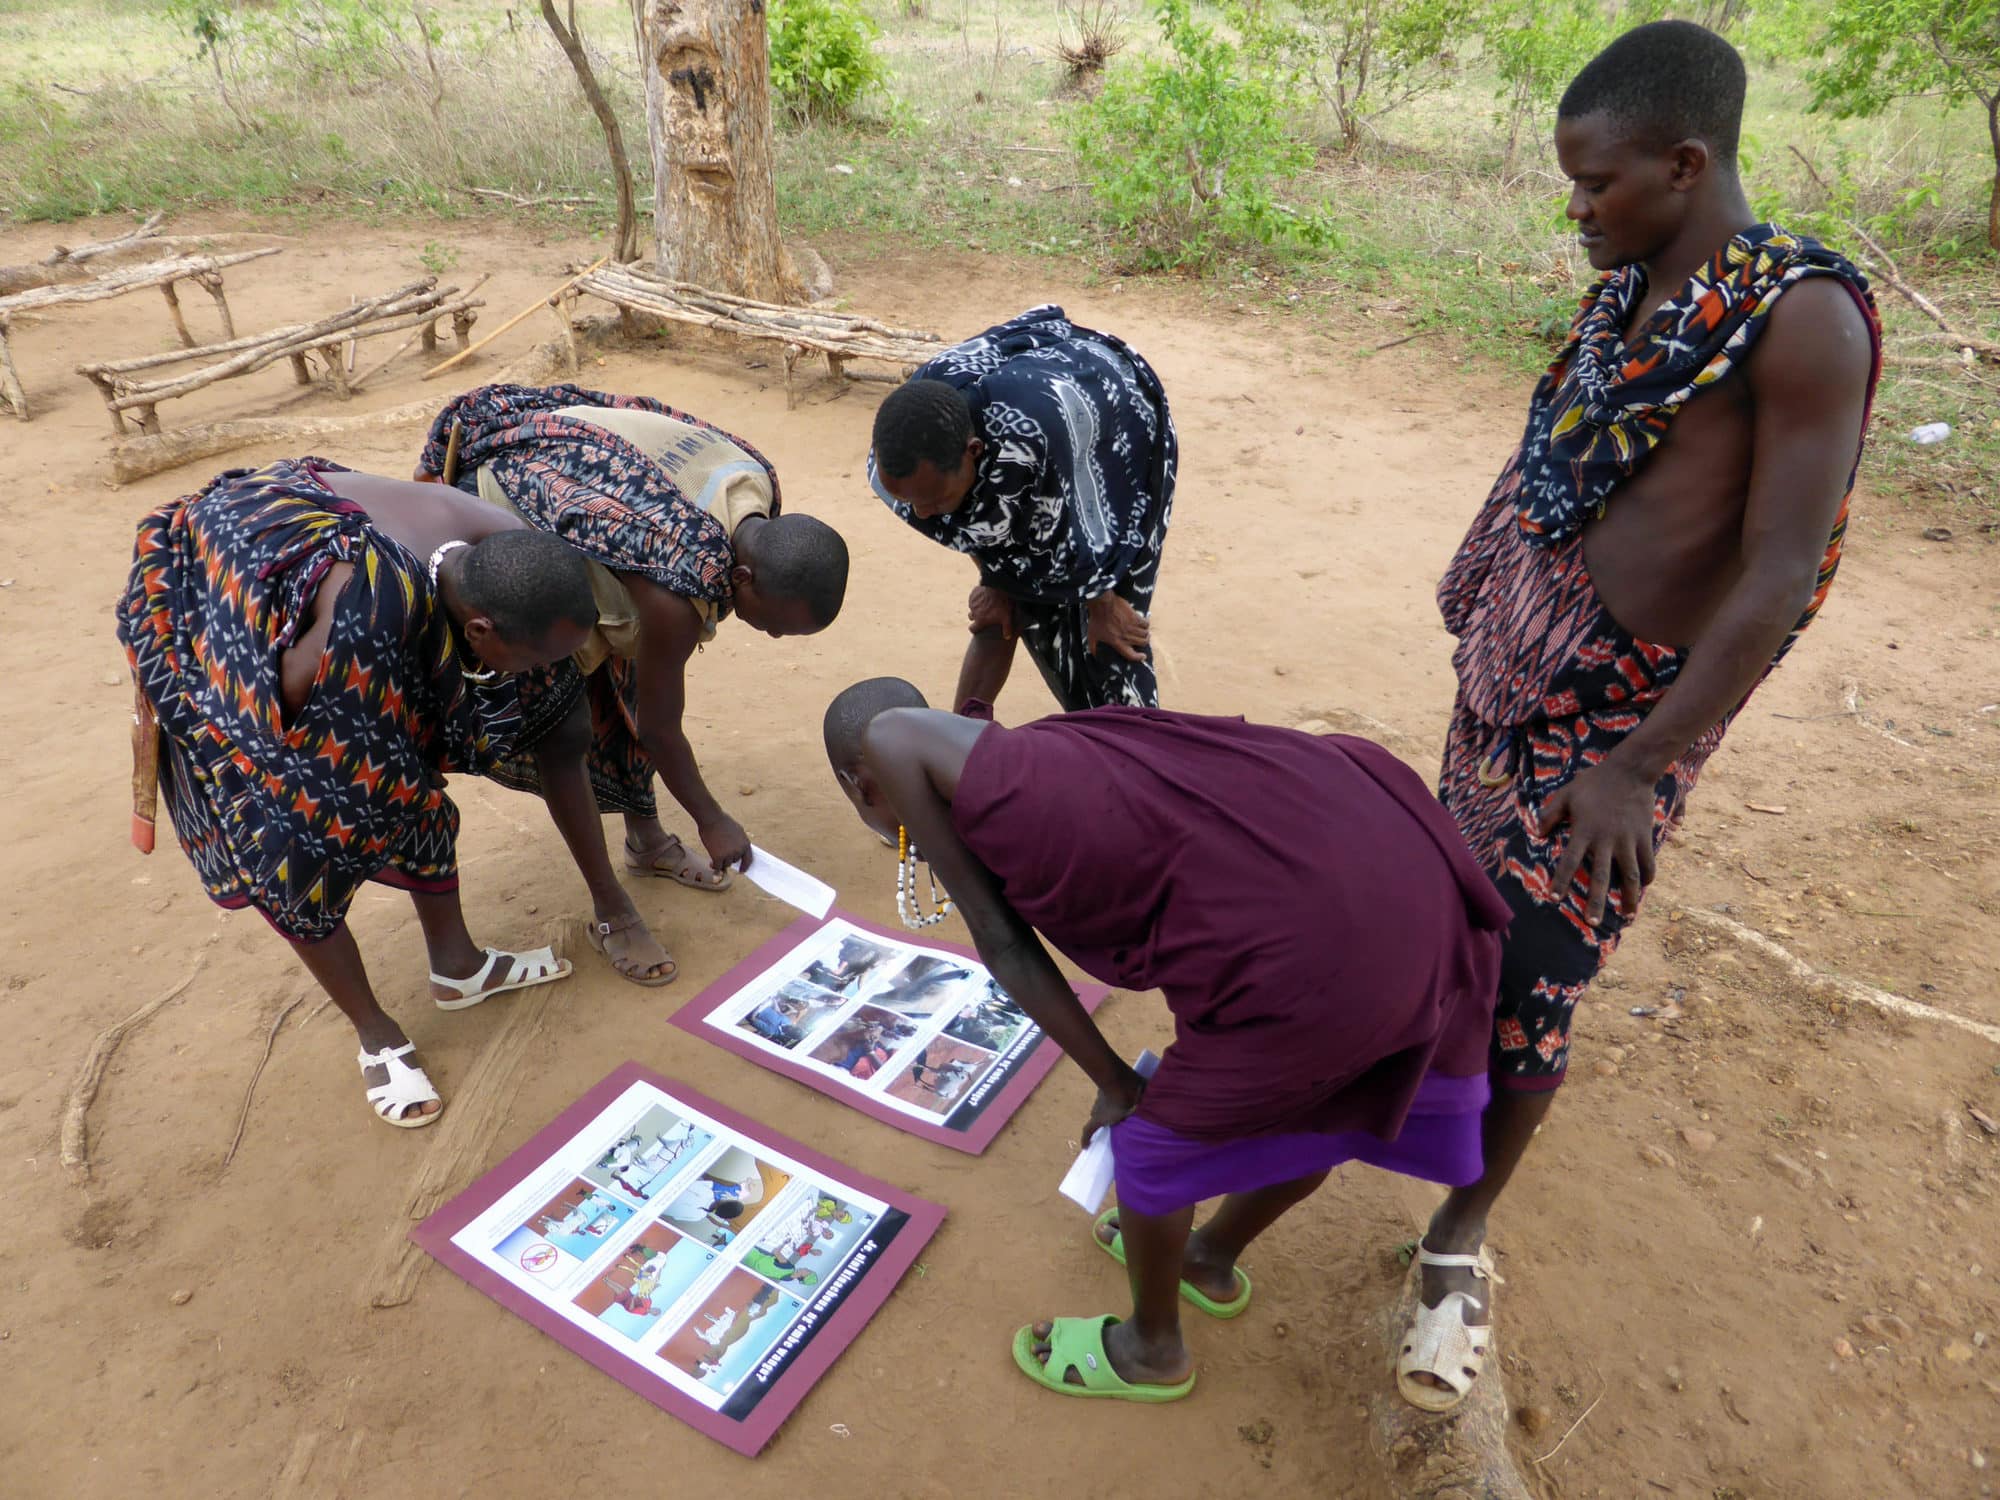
[674,910,1106,1154]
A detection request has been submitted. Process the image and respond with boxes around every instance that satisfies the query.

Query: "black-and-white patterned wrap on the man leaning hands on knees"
[868,306,1180,710]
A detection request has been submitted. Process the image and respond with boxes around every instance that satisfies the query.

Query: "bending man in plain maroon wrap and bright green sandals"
[826,678,1508,1402]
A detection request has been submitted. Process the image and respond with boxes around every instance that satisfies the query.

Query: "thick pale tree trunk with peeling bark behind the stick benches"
[646,0,802,302]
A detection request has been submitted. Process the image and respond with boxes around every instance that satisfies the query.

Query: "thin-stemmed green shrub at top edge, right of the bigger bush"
[1230,0,1478,154]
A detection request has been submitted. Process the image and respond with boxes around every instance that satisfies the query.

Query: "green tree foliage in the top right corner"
[1806,0,2000,250]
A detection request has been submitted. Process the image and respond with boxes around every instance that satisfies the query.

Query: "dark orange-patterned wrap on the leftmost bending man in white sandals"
[116,458,520,942]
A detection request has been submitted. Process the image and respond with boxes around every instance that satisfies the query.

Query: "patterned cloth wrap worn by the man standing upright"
[1438,226,1882,1088]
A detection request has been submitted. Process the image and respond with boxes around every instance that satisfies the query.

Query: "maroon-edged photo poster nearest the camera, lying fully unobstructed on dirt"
[412,1062,944,1454]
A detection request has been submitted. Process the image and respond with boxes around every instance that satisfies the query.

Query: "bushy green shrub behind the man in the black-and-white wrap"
[1070,0,1330,266]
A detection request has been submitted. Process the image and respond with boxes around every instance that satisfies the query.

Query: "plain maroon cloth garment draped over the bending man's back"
[952,708,1508,1142]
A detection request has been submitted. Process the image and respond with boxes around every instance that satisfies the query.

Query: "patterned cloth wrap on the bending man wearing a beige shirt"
[420,386,782,816]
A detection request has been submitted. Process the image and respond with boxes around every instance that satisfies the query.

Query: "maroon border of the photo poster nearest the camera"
[410,1062,944,1458]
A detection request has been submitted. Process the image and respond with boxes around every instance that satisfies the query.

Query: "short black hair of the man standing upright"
[1556,20,1746,172]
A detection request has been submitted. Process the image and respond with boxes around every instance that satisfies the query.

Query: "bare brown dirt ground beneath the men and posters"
[0,214,2000,1500]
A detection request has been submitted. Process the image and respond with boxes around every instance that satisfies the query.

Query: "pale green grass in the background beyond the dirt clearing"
[0,0,2000,516]
